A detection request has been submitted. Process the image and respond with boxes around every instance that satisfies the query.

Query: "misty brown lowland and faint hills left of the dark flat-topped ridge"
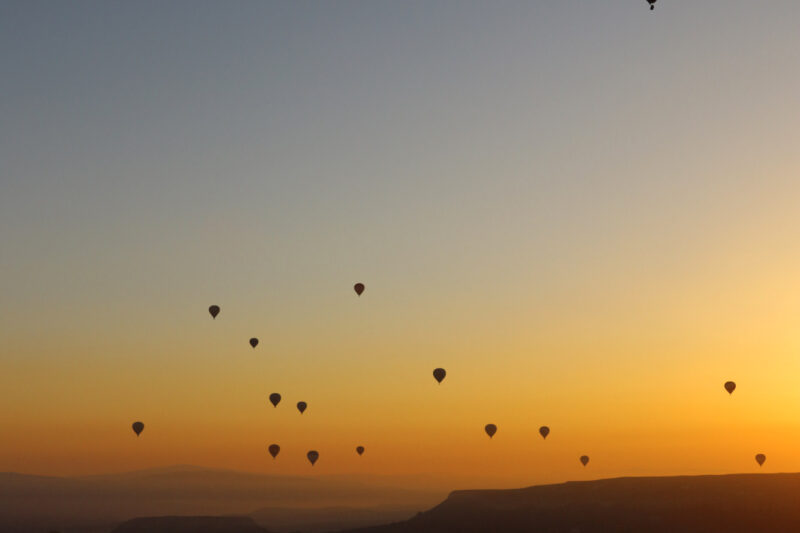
[0,466,440,533]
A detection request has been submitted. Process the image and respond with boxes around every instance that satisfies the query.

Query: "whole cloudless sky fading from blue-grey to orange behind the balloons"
[0,0,800,485]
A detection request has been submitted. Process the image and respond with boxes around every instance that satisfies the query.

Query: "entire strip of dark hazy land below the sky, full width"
[0,467,800,533]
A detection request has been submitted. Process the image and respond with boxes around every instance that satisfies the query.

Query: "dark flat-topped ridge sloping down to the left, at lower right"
[351,474,800,533]
